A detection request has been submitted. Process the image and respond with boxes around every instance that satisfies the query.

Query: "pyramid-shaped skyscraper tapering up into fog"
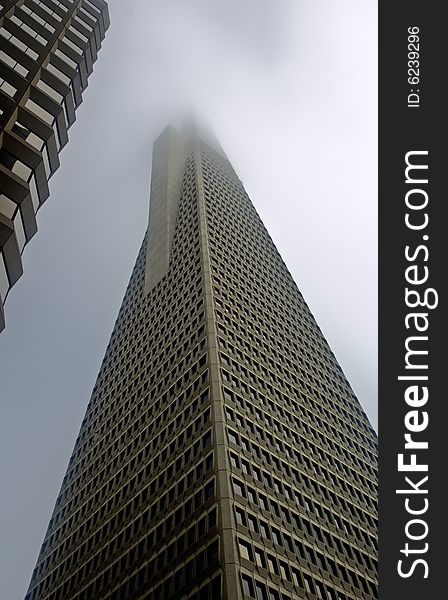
[26,128,377,600]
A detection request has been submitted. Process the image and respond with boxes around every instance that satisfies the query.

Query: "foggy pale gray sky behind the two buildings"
[0,0,377,600]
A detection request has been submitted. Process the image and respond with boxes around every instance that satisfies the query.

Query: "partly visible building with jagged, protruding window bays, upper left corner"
[0,0,109,331]
